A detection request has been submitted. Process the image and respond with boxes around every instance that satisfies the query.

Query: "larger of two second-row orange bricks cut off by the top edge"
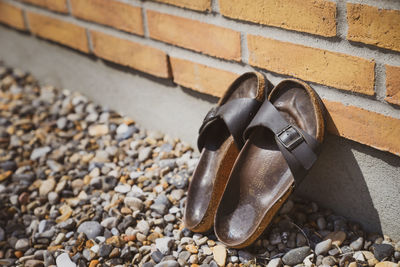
[71,0,143,35]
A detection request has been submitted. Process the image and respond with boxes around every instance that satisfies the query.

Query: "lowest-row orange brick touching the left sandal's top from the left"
[170,58,238,97]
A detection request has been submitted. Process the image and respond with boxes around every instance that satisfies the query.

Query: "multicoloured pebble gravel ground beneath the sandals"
[0,67,400,267]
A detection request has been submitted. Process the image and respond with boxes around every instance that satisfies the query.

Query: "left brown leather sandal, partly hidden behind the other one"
[184,72,271,232]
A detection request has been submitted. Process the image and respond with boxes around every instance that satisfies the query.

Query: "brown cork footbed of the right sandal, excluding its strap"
[214,80,324,248]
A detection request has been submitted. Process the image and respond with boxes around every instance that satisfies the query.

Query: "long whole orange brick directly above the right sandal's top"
[247,35,375,95]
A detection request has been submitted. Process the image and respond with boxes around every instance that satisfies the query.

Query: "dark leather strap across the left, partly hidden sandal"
[197,98,261,151]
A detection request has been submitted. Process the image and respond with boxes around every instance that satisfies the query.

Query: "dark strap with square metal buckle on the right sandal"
[243,100,319,183]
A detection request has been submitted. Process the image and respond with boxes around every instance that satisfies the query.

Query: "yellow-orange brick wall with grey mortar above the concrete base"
[0,0,400,155]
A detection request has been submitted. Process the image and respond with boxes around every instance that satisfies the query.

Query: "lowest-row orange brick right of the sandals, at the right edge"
[324,100,400,155]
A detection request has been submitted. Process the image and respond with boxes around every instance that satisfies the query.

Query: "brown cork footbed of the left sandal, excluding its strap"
[184,73,269,232]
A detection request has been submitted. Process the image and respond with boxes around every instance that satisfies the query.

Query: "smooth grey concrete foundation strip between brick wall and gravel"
[0,26,400,240]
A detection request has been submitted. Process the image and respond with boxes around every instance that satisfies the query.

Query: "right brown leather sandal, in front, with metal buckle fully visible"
[214,79,325,248]
